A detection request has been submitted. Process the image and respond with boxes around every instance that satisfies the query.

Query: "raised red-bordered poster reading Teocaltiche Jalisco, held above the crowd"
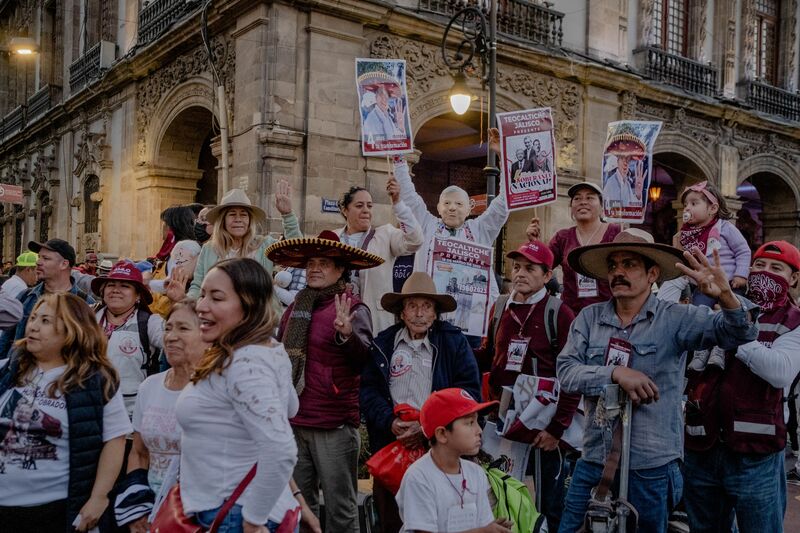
[497,107,557,211]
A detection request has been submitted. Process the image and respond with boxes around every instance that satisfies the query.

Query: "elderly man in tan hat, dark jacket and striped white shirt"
[361,272,480,533]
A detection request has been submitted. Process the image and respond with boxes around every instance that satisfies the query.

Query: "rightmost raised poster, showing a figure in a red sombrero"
[602,120,661,224]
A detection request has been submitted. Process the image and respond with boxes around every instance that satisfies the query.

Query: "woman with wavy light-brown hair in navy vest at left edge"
[0,293,132,533]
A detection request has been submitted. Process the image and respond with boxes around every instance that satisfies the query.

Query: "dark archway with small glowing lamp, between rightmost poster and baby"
[637,152,709,244]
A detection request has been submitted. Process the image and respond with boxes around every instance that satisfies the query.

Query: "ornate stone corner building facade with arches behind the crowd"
[0,0,800,264]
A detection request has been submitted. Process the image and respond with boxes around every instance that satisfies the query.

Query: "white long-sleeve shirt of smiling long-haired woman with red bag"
[176,343,299,524]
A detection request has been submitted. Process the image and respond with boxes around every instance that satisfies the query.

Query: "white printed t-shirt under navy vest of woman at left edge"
[0,365,132,507]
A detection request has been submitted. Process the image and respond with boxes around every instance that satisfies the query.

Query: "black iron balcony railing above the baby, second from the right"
[634,46,717,96]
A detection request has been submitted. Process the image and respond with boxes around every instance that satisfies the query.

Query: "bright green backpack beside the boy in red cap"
[483,466,544,533]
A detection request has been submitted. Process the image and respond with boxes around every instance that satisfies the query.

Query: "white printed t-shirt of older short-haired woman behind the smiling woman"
[133,371,181,494]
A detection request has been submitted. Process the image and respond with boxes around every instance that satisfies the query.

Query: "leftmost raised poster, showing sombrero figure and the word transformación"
[356,58,414,156]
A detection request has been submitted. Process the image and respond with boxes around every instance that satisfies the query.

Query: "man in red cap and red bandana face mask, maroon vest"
[684,241,800,533]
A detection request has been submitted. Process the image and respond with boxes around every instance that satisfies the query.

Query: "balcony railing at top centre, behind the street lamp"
[419,0,564,46]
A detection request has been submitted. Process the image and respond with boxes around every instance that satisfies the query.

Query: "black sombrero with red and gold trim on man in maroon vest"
[264,230,383,270]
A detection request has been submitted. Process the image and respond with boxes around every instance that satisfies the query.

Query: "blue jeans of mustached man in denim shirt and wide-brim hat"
[558,459,680,533]
